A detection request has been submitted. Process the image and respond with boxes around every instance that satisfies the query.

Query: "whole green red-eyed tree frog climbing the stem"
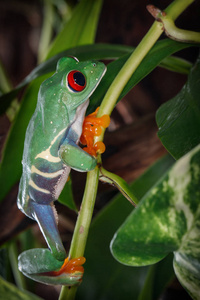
[17,57,106,285]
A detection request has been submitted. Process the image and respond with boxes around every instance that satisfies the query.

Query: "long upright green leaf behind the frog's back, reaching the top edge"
[0,0,101,200]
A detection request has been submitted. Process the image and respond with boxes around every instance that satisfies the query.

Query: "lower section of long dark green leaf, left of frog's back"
[0,77,44,200]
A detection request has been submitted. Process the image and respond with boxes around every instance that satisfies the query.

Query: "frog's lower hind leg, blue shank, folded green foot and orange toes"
[18,201,85,285]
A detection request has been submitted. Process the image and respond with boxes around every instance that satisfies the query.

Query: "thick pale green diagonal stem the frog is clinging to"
[59,0,194,300]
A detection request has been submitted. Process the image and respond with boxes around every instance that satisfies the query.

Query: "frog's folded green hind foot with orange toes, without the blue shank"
[18,249,85,286]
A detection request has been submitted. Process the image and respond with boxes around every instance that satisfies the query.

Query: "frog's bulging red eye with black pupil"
[67,70,86,92]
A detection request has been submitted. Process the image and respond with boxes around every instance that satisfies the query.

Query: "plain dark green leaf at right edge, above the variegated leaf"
[156,58,200,159]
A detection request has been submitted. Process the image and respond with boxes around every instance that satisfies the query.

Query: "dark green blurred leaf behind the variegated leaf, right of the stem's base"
[78,156,174,300]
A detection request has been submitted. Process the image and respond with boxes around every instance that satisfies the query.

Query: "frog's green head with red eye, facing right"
[56,57,106,110]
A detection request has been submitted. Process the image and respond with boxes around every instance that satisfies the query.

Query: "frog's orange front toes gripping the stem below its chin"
[80,107,110,156]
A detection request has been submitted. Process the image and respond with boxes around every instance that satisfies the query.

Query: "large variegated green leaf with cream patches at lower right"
[111,145,200,299]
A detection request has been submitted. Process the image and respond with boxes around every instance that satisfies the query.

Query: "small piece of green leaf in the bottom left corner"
[0,277,42,300]
